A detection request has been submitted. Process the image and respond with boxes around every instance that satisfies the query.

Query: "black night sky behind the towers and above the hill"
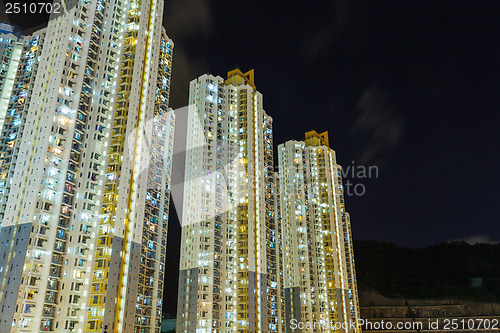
[1,0,500,312]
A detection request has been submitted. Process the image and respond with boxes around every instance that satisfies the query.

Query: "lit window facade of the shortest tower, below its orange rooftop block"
[278,141,359,330]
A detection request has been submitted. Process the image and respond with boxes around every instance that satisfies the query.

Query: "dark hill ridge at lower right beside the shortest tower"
[354,241,500,303]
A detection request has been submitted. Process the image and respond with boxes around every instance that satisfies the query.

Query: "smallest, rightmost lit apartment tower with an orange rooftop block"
[278,131,359,332]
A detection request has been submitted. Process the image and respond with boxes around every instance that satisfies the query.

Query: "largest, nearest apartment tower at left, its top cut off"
[0,0,174,333]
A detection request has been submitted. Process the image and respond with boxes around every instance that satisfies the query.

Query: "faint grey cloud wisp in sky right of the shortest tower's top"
[352,86,404,163]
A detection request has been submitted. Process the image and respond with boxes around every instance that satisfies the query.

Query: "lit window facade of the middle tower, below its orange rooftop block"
[177,75,284,332]
